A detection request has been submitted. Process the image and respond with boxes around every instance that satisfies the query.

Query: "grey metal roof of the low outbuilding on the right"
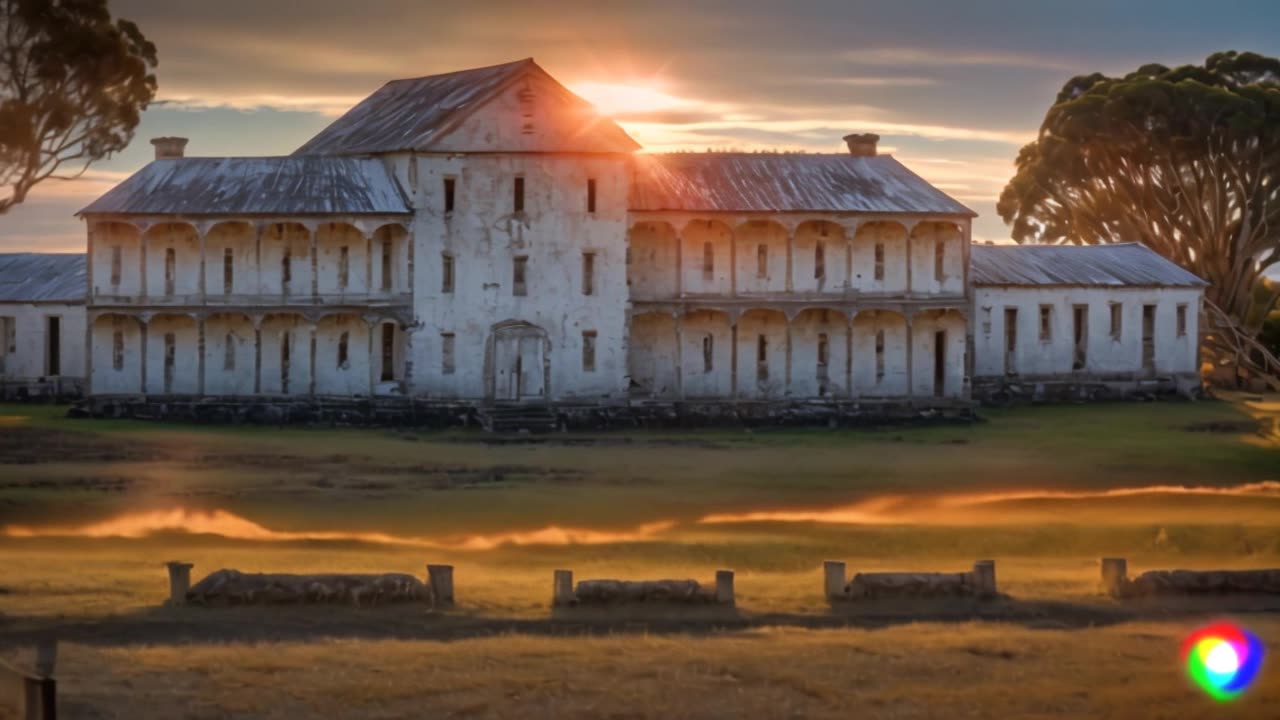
[969,242,1208,287]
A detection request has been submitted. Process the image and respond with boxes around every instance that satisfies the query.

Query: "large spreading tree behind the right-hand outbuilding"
[998,51,1280,381]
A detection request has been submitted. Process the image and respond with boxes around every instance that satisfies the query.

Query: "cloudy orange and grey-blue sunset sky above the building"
[0,0,1280,251]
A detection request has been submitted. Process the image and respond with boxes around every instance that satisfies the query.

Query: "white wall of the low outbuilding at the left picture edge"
[0,302,84,380]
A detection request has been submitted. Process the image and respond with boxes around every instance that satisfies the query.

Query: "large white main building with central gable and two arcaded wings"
[64,60,1203,420]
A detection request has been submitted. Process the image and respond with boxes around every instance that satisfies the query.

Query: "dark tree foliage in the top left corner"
[0,0,156,213]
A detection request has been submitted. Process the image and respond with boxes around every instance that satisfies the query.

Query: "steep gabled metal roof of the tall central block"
[294,58,640,155]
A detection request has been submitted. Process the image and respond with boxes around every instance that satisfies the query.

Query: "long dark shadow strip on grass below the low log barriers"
[0,596,1280,647]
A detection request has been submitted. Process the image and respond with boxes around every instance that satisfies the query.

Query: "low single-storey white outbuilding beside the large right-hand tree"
[970,242,1208,401]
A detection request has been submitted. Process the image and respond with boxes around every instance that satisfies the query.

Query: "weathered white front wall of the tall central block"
[393,154,632,400]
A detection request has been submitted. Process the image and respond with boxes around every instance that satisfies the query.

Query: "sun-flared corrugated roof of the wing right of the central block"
[631,152,975,215]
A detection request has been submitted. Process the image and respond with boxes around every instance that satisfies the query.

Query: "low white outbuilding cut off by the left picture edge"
[0,252,88,398]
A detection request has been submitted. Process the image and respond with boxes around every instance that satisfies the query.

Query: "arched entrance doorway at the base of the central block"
[484,320,552,402]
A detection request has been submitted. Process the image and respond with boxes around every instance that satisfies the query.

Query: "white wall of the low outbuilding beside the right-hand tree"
[973,287,1202,377]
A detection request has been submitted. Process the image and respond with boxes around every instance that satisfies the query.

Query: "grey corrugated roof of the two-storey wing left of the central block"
[81,155,411,215]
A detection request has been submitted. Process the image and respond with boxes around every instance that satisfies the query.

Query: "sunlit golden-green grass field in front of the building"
[0,400,1280,717]
